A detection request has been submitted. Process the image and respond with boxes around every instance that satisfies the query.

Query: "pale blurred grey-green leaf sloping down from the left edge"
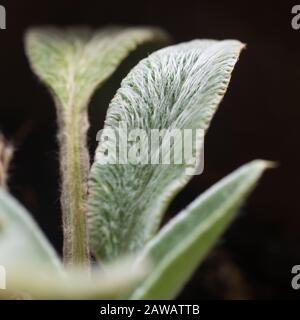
[0,190,62,273]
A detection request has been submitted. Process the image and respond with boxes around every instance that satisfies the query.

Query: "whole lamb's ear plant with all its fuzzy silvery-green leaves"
[0,28,269,299]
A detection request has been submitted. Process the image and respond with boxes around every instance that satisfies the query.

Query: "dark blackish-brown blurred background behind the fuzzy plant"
[0,0,300,299]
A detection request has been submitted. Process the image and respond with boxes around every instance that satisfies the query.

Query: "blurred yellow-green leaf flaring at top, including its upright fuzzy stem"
[26,27,168,264]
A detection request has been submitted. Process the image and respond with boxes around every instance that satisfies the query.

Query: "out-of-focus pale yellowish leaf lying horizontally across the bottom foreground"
[0,261,148,300]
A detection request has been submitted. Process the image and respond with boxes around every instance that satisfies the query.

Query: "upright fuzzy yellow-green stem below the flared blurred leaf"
[58,103,89,267]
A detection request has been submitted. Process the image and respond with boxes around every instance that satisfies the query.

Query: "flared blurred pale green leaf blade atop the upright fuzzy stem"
[25,27,168,113]
